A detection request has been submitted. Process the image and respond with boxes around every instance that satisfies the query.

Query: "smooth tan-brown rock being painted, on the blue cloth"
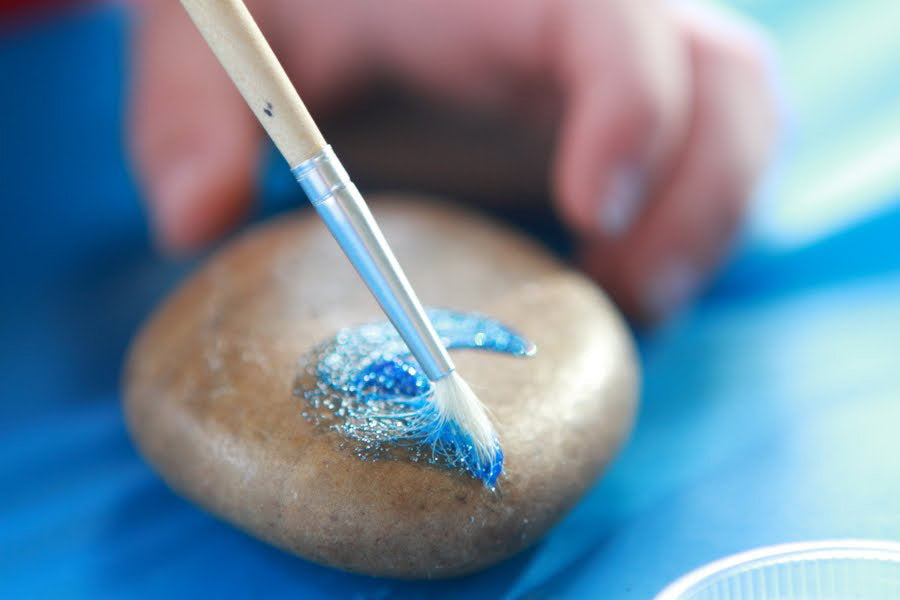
[125,198,638,578]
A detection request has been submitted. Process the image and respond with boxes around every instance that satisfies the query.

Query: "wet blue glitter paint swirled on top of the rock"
[296,309,535,488]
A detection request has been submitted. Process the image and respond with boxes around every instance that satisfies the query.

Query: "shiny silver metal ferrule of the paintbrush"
[291,146,454,381]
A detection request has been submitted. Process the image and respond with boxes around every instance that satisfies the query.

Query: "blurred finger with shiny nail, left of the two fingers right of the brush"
[555,1,689,238]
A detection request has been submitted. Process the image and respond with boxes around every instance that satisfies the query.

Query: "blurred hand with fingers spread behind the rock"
[131,0,775,319]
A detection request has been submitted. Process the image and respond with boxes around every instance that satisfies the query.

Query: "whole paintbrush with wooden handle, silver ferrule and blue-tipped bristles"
[175,0,502,472]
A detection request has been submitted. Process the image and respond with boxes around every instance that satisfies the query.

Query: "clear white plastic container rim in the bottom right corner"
[655,540,900,600]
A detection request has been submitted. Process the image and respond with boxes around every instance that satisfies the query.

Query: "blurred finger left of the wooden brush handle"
[130,0,260,253]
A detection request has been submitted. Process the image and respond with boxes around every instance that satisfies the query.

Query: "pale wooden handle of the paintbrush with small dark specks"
[181,0,325,167]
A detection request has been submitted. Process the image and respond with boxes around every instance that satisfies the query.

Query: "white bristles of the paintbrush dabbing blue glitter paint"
[433,371,497,463]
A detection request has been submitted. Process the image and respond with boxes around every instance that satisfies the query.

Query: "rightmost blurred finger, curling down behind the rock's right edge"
[582,4,775,321]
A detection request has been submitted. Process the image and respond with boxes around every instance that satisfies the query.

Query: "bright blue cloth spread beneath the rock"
[0,8,900,598]
